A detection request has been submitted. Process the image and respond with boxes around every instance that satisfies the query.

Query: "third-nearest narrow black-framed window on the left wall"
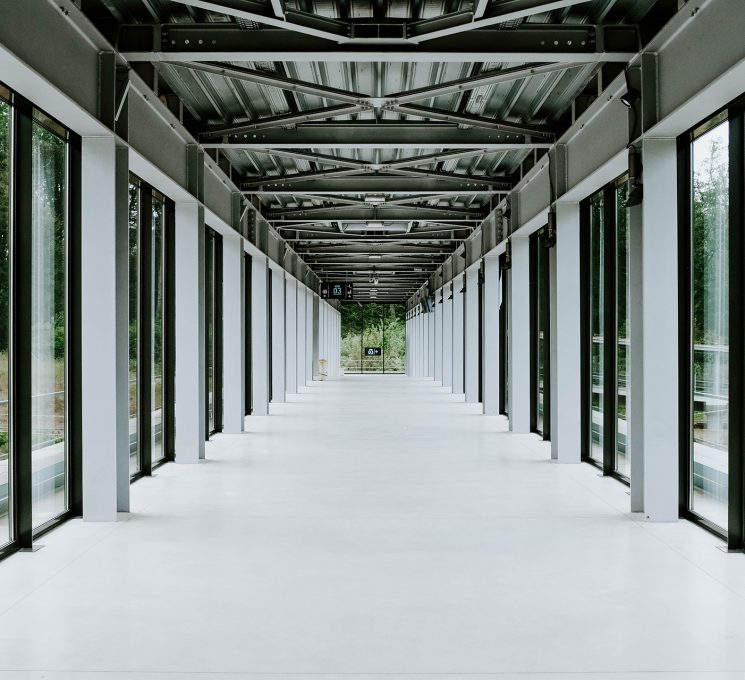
[205,228,222,437]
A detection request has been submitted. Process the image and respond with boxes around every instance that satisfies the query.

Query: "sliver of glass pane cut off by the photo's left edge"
[0,101,13,545]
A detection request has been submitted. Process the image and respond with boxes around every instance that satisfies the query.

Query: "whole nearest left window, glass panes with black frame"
[0,84,81,556]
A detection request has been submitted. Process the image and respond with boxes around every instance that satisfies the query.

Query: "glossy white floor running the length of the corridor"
[0,376,745,680]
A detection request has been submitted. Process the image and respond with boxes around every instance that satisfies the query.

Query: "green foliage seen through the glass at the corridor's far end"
[341,303,406,373]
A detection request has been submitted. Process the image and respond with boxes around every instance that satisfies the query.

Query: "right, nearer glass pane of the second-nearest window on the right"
[616,182,631,477]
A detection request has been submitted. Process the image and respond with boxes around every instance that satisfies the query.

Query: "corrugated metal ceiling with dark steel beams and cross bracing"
[97,0,657,300]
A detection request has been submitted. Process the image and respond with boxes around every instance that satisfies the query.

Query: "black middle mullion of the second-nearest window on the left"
[137,184,153,476]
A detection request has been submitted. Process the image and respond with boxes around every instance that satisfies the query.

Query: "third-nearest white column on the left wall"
[222,234,246,433]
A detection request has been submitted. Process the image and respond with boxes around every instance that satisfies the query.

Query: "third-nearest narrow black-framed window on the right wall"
[530,229,551,439]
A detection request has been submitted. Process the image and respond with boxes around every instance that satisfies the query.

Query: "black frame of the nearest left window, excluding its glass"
[0,83,83,559]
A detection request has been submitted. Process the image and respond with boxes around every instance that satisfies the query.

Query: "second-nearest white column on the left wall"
[175,203,206,463]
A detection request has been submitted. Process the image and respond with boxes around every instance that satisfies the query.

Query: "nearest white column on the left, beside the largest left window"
[80,137,118,522]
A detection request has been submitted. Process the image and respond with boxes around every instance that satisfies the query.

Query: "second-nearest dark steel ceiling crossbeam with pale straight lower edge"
[203,121,551,151]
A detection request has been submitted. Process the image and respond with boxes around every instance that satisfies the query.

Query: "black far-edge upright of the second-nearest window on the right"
[579,201,592,462]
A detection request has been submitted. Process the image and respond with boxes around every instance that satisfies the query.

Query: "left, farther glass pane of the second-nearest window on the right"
[589,196,605,463]
